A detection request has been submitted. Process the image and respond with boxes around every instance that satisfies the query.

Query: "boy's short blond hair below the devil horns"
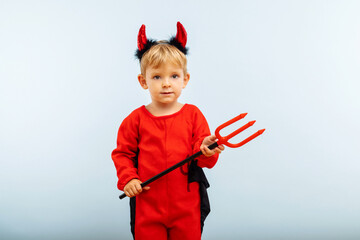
[140,41,187,75]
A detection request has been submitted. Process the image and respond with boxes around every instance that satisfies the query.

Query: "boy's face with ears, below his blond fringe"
[138,63,190,105]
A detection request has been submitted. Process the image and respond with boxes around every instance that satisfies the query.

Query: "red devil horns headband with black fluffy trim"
[135,22,188,61]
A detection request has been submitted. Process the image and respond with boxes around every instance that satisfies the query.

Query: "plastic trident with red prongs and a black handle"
[120,113,265,199]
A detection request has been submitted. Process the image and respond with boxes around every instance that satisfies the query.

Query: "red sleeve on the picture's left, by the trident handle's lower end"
[111,114,139,190]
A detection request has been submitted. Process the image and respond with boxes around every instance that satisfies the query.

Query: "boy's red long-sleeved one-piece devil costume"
[112,104,218,240]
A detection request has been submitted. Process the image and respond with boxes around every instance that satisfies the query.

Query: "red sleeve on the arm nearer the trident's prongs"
[192,108,219,168]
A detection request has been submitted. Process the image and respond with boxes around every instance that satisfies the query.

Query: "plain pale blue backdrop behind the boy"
[0,0,360,240]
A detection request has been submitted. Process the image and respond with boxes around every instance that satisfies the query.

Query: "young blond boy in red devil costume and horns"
[112,22,224,240]
